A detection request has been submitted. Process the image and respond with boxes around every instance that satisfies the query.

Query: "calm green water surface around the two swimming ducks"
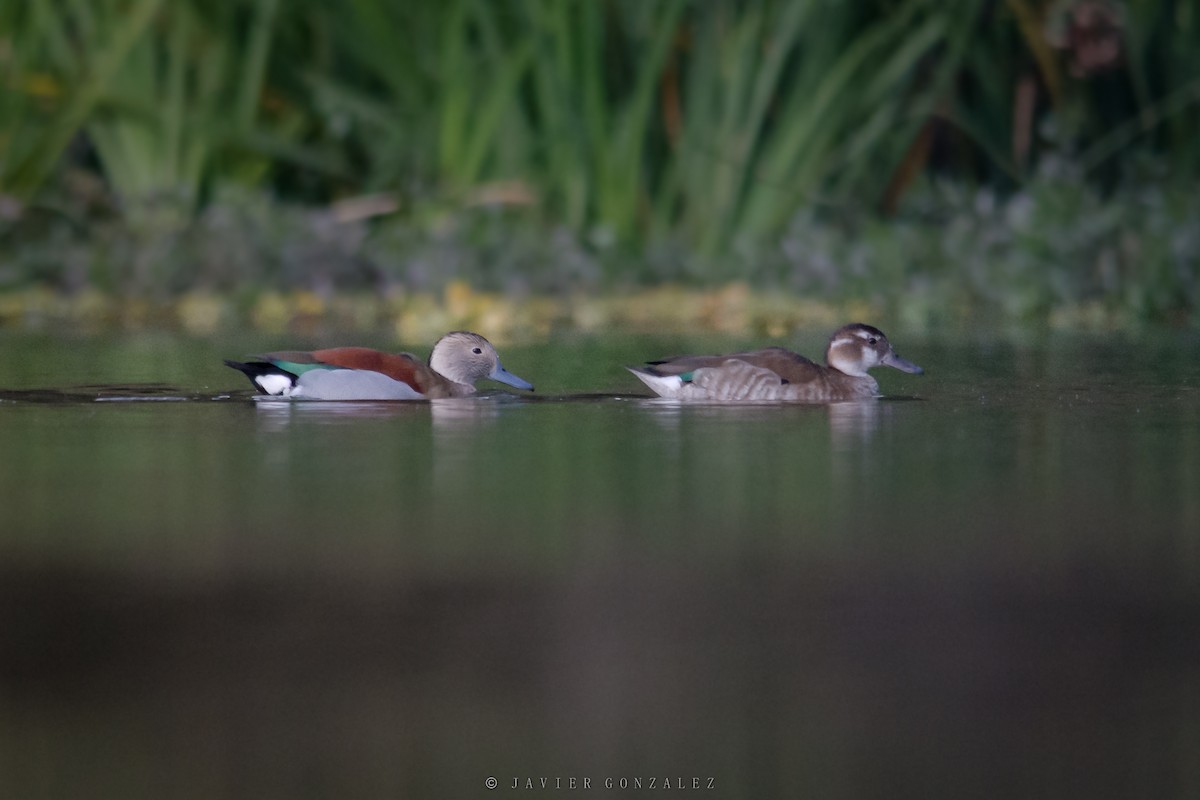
[0,333,1200,798]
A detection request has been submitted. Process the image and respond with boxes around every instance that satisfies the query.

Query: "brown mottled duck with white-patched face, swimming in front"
[626,323,924,403]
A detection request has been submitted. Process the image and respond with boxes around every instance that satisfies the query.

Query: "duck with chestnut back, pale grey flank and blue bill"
[226,331,533,401]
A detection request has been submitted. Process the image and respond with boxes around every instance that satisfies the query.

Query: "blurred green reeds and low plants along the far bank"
[0,0,1200,324]
